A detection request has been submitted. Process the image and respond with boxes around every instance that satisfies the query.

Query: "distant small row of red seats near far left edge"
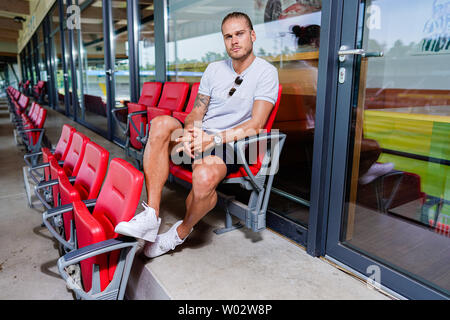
[6,86,47,152]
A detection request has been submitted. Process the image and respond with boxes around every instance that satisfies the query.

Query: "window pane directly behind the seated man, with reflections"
[166,0,322,225]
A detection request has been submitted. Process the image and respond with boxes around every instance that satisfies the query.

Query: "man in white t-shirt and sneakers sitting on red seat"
[115,12,278,257]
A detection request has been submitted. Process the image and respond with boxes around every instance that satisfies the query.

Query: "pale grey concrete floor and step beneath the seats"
[0,101,389,300]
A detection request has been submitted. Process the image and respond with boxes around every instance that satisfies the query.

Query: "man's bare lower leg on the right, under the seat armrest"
[177,156,227,239]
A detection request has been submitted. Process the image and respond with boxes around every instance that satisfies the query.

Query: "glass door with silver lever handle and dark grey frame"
[326,0,450,299]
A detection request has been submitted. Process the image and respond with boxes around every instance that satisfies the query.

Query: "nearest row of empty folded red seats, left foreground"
[24,124,144,299]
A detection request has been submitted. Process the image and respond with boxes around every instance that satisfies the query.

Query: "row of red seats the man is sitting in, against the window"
[114,82,286,232]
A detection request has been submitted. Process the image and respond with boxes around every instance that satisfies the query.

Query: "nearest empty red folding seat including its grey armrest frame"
[58,158,144,299]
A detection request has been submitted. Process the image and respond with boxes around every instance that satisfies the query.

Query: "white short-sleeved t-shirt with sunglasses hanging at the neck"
[198,57,278,134]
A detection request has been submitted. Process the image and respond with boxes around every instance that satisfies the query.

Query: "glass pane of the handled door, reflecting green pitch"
[341,0,450,294]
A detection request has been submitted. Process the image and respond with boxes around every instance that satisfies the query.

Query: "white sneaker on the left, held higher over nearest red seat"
[114,202,161,242]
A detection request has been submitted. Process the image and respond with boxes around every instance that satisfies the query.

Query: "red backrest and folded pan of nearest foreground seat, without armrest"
[74,158,144,292]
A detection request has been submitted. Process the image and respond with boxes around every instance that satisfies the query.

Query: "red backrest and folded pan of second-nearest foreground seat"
[58,141,109,240]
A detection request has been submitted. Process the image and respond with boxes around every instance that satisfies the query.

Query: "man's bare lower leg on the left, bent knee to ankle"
[143,116,182,217]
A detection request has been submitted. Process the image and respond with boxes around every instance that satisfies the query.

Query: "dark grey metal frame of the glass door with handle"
[318,0,448,299]
